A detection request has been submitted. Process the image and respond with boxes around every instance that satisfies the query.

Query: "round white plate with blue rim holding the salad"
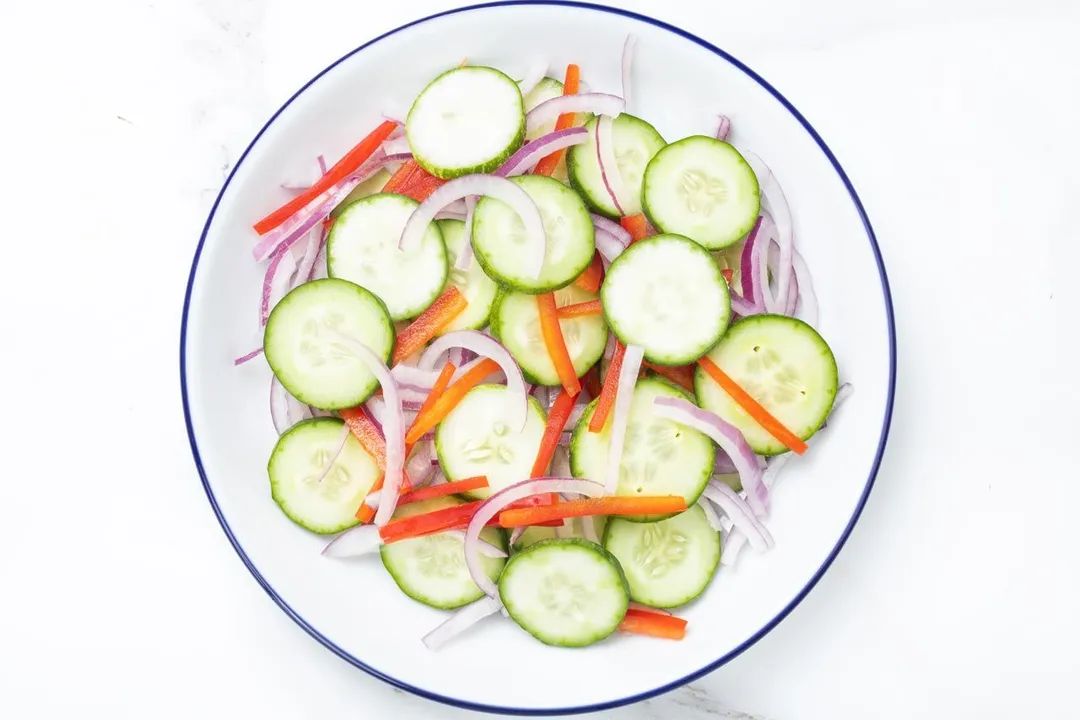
[180,2,895,714]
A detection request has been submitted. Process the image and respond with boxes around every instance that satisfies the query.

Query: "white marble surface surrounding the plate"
[0,0,1080,720]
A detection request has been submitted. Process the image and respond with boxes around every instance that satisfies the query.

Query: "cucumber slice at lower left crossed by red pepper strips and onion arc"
[379,498,507,610]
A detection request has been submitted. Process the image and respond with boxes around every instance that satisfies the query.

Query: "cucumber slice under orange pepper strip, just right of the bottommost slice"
[604,505,720,608]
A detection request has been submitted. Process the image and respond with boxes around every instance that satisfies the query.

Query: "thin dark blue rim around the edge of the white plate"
[180,0,896,716]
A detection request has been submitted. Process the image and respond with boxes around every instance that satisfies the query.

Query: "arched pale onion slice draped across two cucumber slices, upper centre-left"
[399,174,548,277]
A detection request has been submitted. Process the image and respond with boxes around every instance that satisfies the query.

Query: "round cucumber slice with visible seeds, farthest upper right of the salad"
[642,135,760,250]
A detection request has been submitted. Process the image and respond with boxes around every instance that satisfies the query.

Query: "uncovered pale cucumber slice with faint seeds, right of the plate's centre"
[600,235,731,365]
